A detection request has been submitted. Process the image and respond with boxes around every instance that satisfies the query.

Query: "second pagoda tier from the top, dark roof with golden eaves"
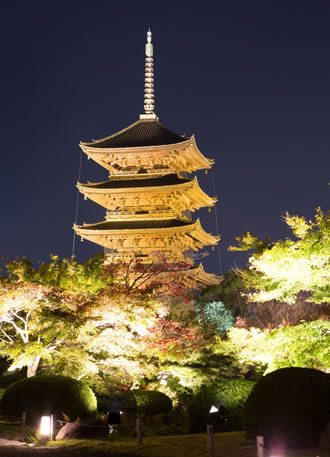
[77,174,217,220]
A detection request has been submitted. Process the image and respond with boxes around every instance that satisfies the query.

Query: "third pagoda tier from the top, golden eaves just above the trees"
[74,219,220,262]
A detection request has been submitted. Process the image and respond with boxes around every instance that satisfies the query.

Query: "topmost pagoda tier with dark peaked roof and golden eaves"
[80,118,214,179]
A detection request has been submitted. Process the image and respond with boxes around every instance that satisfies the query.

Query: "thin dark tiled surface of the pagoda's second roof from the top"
[82,174,190,189]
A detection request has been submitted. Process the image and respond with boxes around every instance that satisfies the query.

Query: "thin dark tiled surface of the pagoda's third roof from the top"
[79,219,194,230]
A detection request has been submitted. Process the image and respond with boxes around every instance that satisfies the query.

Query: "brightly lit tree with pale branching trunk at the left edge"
[0,281,93,377]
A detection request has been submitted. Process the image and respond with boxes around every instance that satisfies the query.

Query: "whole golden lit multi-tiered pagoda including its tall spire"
[73,29,220,287]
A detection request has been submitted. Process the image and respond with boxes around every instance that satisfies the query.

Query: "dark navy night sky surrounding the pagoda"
[0,0,330,273]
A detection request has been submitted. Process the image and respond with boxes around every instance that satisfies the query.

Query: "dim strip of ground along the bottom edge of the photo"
[0,432,330,457]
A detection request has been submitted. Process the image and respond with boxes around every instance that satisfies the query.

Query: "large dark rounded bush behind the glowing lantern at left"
[1,376,97,423]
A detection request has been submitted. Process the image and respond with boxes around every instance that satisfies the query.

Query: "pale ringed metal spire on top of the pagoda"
[141,28,156,119]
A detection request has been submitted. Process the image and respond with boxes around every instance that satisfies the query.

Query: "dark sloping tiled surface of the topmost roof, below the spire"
[81,120,188,149]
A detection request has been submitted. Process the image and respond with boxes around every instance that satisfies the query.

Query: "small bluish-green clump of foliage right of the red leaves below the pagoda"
[196,301,235,335]
